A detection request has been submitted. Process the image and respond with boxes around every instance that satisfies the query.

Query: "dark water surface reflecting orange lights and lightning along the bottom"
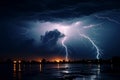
[0,63,120,80]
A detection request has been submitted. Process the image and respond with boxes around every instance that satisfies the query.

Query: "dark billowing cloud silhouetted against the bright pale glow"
[32,29,65,58]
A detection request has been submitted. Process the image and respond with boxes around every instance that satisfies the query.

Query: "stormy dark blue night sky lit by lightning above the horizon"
[0,0,120,59]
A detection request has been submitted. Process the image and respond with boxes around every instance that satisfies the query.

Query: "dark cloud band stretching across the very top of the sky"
[0,0,120,21]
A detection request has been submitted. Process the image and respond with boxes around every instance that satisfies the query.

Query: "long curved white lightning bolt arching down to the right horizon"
[79,33,100,59]
